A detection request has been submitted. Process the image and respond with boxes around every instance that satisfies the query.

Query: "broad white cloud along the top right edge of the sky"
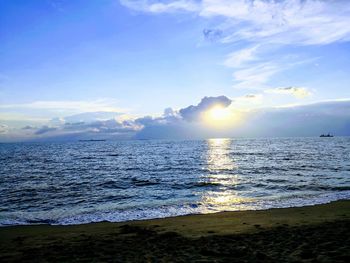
[120,0,350,45]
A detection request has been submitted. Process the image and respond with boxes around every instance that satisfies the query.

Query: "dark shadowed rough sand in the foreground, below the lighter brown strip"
[0,220,350,262]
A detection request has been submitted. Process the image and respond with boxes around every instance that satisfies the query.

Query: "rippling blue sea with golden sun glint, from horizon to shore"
[0,137,350,226]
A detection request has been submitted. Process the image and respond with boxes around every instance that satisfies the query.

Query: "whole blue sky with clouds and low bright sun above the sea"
[0,0,350,142]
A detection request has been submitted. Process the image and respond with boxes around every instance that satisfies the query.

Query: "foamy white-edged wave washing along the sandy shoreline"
[0,191,350,226]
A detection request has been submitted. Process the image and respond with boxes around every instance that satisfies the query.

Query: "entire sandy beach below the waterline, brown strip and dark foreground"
[0,200,350,262]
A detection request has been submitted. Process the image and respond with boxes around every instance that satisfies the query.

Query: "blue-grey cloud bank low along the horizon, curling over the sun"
[14,96,350,141]
